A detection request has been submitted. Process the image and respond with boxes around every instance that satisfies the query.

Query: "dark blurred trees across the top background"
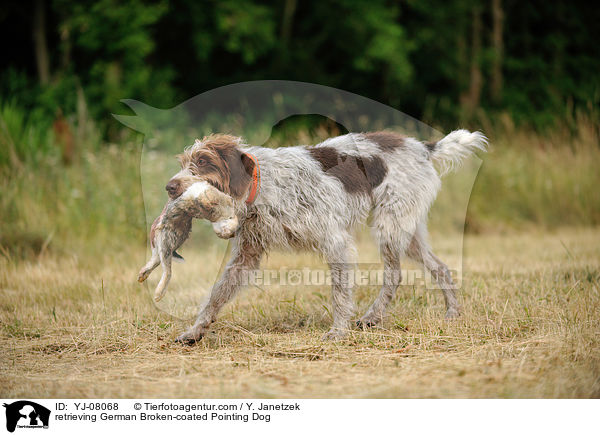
[0,0,600,133]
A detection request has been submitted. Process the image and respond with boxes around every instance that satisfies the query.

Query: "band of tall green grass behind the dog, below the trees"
[0,107,600,257]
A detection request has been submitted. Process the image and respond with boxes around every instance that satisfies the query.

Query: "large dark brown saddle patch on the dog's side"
[308,147,387,193]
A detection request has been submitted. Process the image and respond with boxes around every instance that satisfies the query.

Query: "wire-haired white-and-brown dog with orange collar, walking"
[166,130,487,344]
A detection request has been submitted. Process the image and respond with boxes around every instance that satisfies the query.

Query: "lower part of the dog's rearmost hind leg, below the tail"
[407,222,460,319]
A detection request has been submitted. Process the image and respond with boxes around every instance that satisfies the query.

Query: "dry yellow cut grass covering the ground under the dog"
[0,229,600,398]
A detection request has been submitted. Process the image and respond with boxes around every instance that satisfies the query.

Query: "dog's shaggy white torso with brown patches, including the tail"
[237,130,484,254]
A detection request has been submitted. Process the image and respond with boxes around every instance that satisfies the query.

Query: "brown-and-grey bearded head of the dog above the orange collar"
[165,134,254,199]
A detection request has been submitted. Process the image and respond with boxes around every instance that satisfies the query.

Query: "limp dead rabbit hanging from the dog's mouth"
[138,181,238,302]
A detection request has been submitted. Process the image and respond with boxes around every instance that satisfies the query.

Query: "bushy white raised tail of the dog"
[427,130,488,175]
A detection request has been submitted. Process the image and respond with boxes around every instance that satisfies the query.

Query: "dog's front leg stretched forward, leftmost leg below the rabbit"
[176,240,262,344]
